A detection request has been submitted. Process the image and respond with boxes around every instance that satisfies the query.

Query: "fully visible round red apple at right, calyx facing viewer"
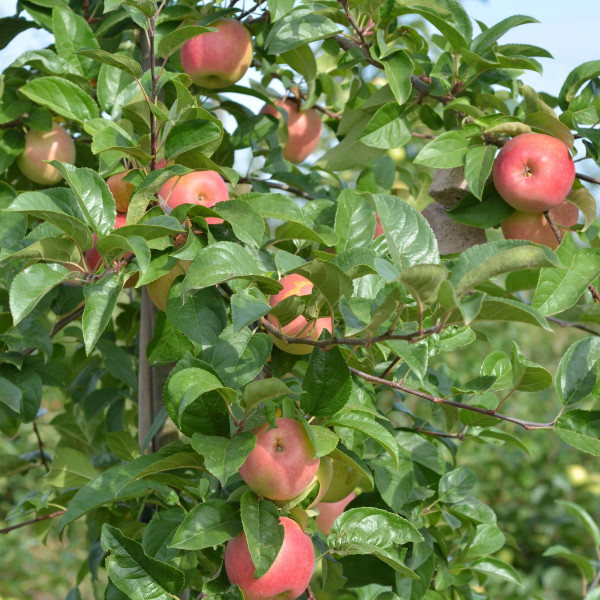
[492,133,575,212]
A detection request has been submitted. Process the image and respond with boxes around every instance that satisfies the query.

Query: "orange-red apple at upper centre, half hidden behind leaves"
[260,99,322,163]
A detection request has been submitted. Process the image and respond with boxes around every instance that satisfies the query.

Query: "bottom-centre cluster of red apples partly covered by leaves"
[225,418,358,600]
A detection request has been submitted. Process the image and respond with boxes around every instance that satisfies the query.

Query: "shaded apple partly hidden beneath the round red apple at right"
[500,201,579,250]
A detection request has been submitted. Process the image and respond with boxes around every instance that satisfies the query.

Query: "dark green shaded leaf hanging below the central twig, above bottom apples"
[300,346,352,417]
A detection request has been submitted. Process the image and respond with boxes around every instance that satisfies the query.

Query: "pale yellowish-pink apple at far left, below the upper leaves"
[17,123,75,185]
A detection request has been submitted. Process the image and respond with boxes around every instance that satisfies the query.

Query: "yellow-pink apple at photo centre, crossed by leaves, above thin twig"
[267,273,332,354]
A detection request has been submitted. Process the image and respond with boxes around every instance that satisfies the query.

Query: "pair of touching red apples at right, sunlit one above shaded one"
[492,133,579,249]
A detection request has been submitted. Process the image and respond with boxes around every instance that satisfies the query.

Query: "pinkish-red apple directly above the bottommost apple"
[239,418,320,500]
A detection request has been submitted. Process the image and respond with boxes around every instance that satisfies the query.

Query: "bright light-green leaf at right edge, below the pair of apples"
[532,236,600,315]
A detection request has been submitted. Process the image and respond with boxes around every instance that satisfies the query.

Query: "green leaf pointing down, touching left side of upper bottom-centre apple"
[192,432,256,487]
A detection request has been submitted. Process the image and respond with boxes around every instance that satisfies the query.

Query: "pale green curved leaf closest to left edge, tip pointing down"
[9,263,78,325]
